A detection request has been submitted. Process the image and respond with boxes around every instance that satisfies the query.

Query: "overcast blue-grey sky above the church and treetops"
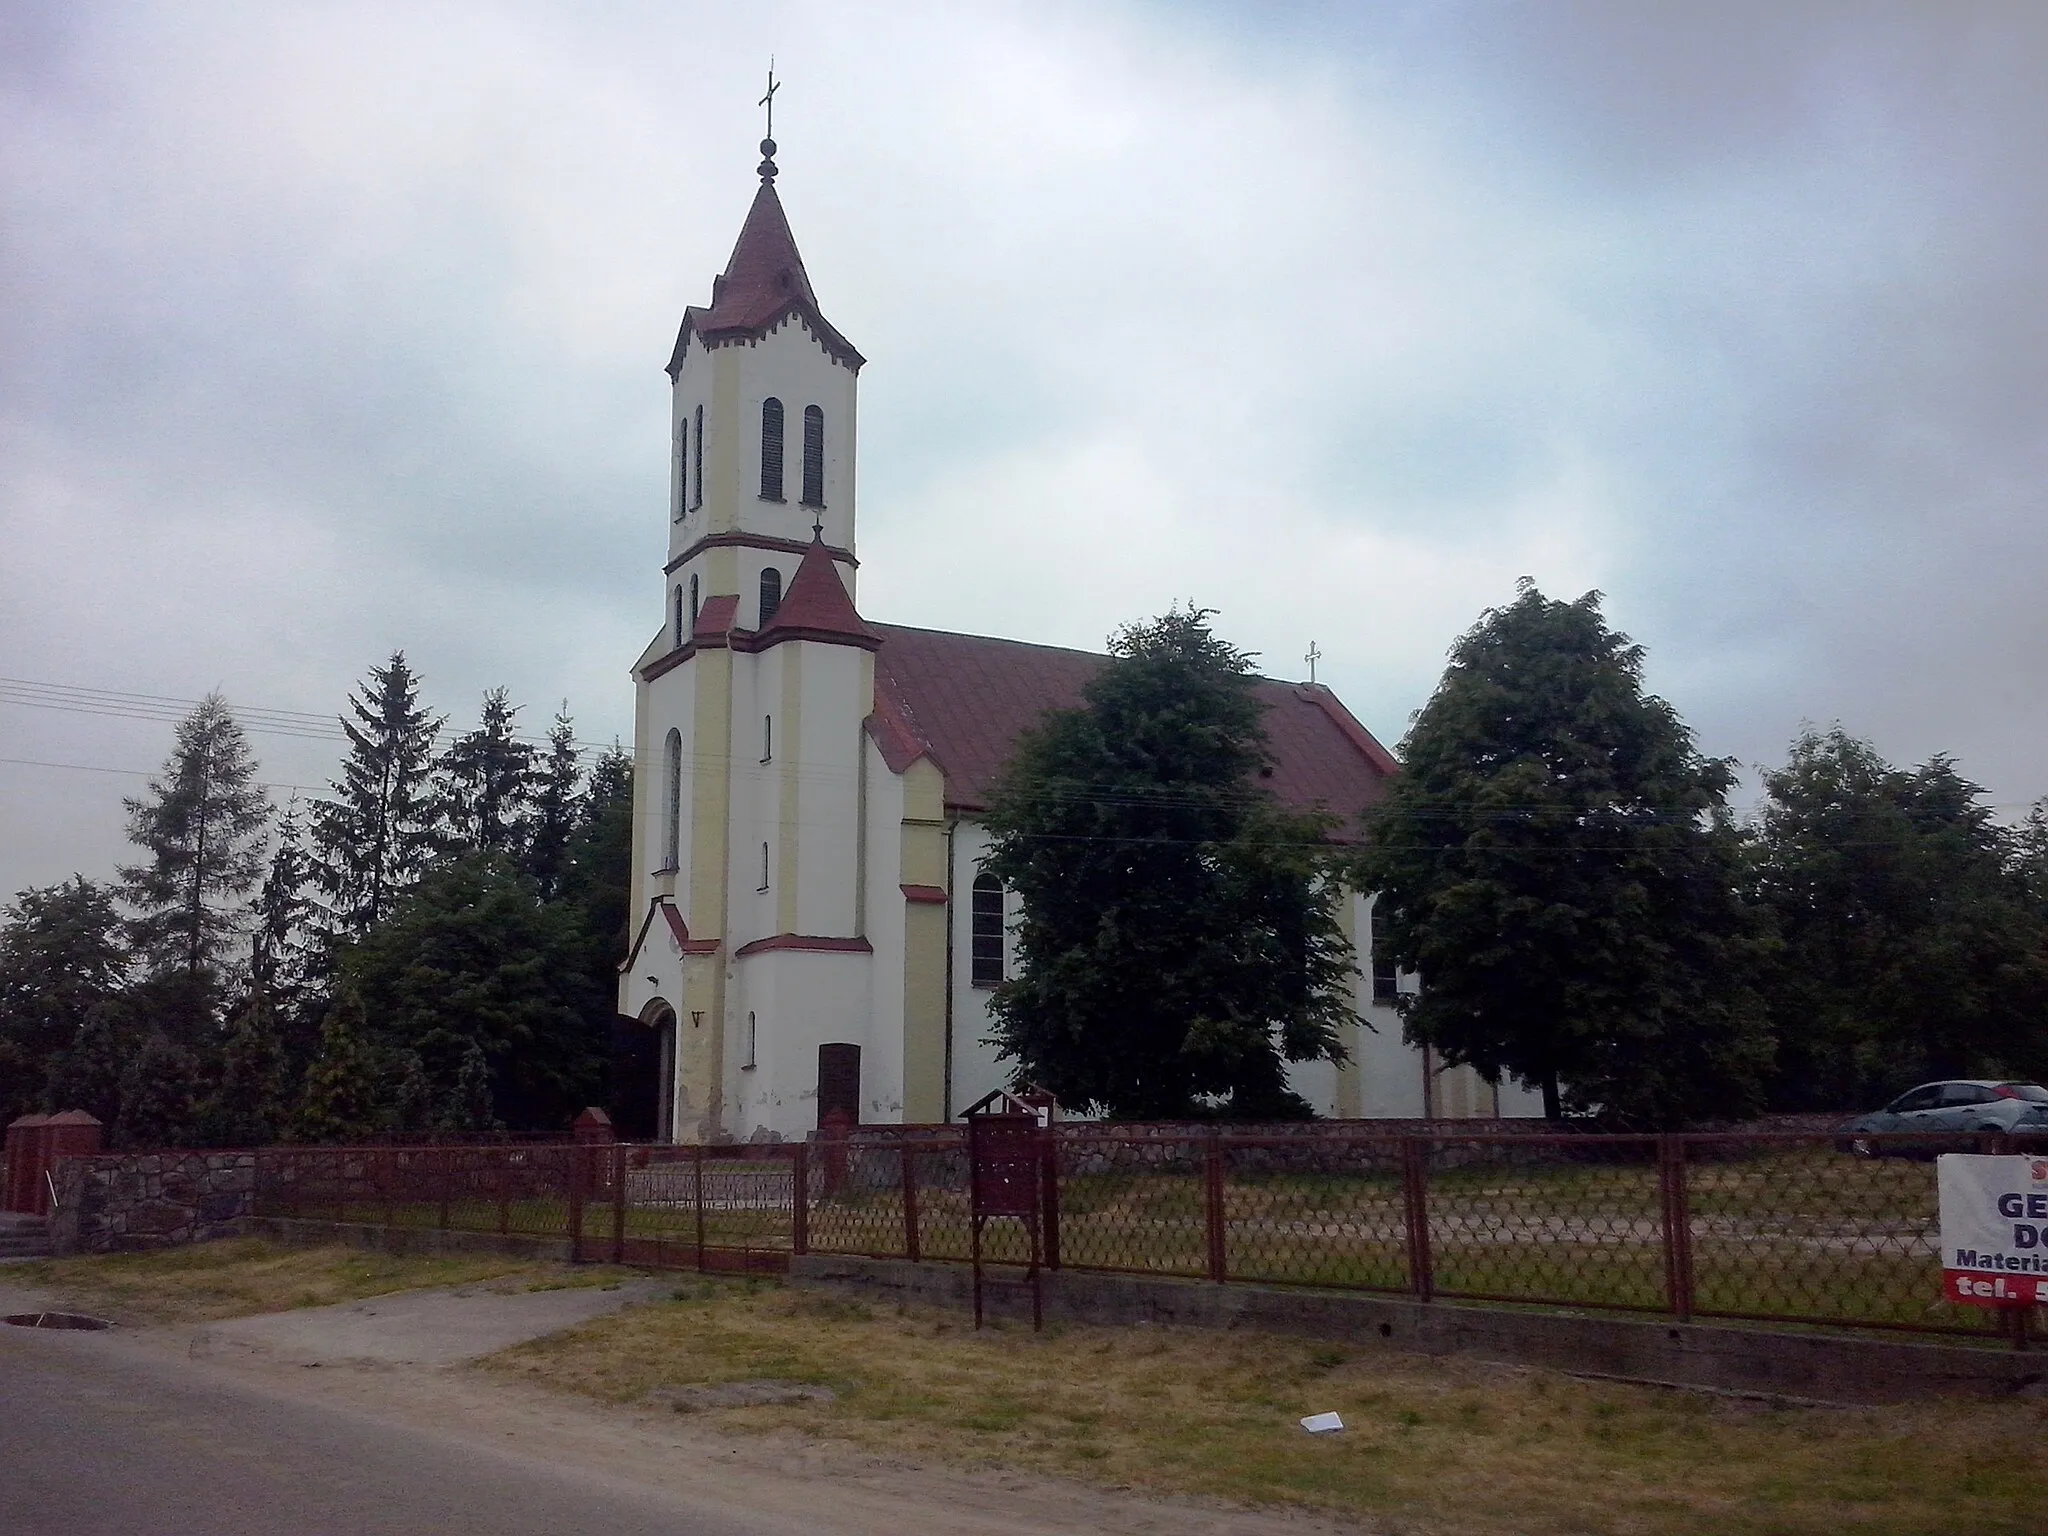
[0,0,2048,899]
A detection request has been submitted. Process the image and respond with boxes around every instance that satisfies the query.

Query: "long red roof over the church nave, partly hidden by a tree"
[868,625,1399,838]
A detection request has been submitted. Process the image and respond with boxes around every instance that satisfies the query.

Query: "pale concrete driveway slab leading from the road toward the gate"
[193,1280,676,1366]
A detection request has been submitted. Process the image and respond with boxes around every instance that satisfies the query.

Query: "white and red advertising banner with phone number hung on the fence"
[1937,1153,2048,1307]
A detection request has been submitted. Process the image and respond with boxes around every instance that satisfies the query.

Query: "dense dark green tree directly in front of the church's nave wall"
[985,608,1354,1118]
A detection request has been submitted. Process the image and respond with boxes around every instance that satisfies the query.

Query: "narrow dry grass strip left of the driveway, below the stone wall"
[33,1237,621,1323]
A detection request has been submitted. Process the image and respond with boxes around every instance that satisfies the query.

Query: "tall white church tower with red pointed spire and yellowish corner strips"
[621,129,881,1141]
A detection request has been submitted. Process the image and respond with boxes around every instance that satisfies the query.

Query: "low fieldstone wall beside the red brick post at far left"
[49,1151,256,1253]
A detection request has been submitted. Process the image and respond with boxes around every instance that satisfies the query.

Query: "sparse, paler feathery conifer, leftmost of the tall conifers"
[121,694,270,1028]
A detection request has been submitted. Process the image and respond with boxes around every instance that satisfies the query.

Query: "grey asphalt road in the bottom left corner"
[0,1327,753,1536]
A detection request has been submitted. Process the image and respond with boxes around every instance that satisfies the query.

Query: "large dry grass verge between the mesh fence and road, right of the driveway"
[489,1280,2048,1536]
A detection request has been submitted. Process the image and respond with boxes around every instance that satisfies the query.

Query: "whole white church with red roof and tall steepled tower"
[618,139,1540,1143]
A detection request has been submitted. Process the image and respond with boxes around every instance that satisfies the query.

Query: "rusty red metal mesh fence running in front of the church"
[254,1124,2032,1333]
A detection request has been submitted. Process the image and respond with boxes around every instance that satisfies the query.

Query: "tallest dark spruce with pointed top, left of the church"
[311,651,442,942]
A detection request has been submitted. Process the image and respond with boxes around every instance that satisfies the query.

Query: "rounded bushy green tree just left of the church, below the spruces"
[342,854,610,1133]
